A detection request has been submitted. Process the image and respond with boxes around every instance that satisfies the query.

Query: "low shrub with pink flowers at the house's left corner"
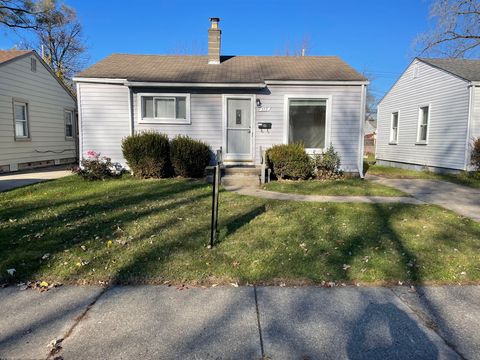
[73,150,121,181]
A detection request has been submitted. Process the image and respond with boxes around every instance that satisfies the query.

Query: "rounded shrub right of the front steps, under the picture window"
[266,144,313,180]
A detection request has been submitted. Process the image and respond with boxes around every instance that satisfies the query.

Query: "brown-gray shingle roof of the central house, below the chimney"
[78,54,367,83]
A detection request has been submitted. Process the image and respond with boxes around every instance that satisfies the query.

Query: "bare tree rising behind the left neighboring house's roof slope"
[33,0,87,83]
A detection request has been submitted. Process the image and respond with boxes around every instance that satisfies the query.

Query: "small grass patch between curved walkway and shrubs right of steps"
[264,179,407,196]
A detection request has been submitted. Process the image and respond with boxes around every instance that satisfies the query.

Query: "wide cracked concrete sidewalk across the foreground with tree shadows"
[0,286,480,360]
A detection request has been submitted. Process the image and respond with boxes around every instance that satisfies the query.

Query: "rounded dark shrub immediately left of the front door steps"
[170,135,211,178]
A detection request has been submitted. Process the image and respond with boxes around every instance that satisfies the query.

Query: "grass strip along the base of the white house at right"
[368,165,480,188]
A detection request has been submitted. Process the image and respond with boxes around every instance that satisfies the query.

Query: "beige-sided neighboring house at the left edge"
[0,50,77,173]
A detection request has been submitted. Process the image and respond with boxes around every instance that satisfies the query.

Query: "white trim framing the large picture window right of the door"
[283,94,332,154]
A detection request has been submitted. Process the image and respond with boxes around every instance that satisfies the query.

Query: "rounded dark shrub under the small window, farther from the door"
[122,131,171,178]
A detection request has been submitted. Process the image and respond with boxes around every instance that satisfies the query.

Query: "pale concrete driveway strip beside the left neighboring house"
[0,165,72,192]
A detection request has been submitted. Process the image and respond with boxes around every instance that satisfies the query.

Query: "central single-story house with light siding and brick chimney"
[74,18,368,174]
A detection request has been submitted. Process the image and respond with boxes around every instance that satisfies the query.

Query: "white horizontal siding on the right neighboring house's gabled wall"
[376,60,469,170]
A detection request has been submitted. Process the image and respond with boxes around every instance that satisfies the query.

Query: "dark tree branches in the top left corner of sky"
[0,0,38,29]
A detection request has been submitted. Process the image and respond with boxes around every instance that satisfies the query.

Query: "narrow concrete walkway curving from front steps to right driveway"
[225,186,424,205]
